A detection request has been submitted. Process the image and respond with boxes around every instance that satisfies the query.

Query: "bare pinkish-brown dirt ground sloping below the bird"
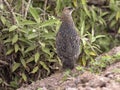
[17,62,120,90]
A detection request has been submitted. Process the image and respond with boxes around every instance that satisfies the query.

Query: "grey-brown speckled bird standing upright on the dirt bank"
[56,7,80,69]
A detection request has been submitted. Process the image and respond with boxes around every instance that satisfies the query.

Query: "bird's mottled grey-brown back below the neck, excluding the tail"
[56,23,80,57]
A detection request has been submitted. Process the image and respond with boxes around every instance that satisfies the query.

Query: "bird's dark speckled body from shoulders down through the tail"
[56,23,80,68]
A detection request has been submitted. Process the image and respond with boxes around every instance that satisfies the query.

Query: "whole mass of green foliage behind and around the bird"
[0,0,120,89]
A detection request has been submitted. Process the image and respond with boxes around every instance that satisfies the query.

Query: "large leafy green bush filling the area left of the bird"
[1,1,60,88]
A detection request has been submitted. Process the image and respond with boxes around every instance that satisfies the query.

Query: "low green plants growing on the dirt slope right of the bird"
[89,53,120,73]
